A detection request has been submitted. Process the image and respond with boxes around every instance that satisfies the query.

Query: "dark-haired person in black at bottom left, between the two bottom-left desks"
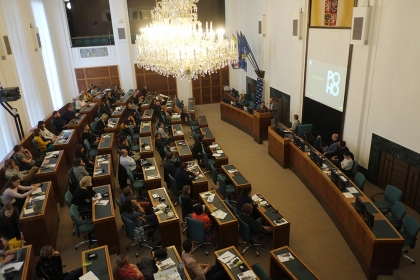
[36,245,83,280]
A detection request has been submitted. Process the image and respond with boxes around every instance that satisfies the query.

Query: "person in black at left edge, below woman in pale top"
[0,204,25,249]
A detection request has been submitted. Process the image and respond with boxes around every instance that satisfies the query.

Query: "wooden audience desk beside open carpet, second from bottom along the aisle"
[256,194,290,249]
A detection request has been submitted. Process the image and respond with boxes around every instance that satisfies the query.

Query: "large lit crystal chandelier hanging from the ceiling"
[136,0,238,80]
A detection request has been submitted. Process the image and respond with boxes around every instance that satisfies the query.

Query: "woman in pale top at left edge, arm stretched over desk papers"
[0,175,37,210]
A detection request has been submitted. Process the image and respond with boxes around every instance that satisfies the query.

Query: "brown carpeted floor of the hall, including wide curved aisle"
[56,104,420,279]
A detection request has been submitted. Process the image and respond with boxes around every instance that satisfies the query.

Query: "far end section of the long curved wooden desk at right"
[268,126,292,168]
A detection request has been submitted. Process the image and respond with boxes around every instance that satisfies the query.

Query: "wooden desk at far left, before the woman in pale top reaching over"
[19,182,60,255]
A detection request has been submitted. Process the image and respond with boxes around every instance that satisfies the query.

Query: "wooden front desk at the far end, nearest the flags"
[220,102,271,144]
